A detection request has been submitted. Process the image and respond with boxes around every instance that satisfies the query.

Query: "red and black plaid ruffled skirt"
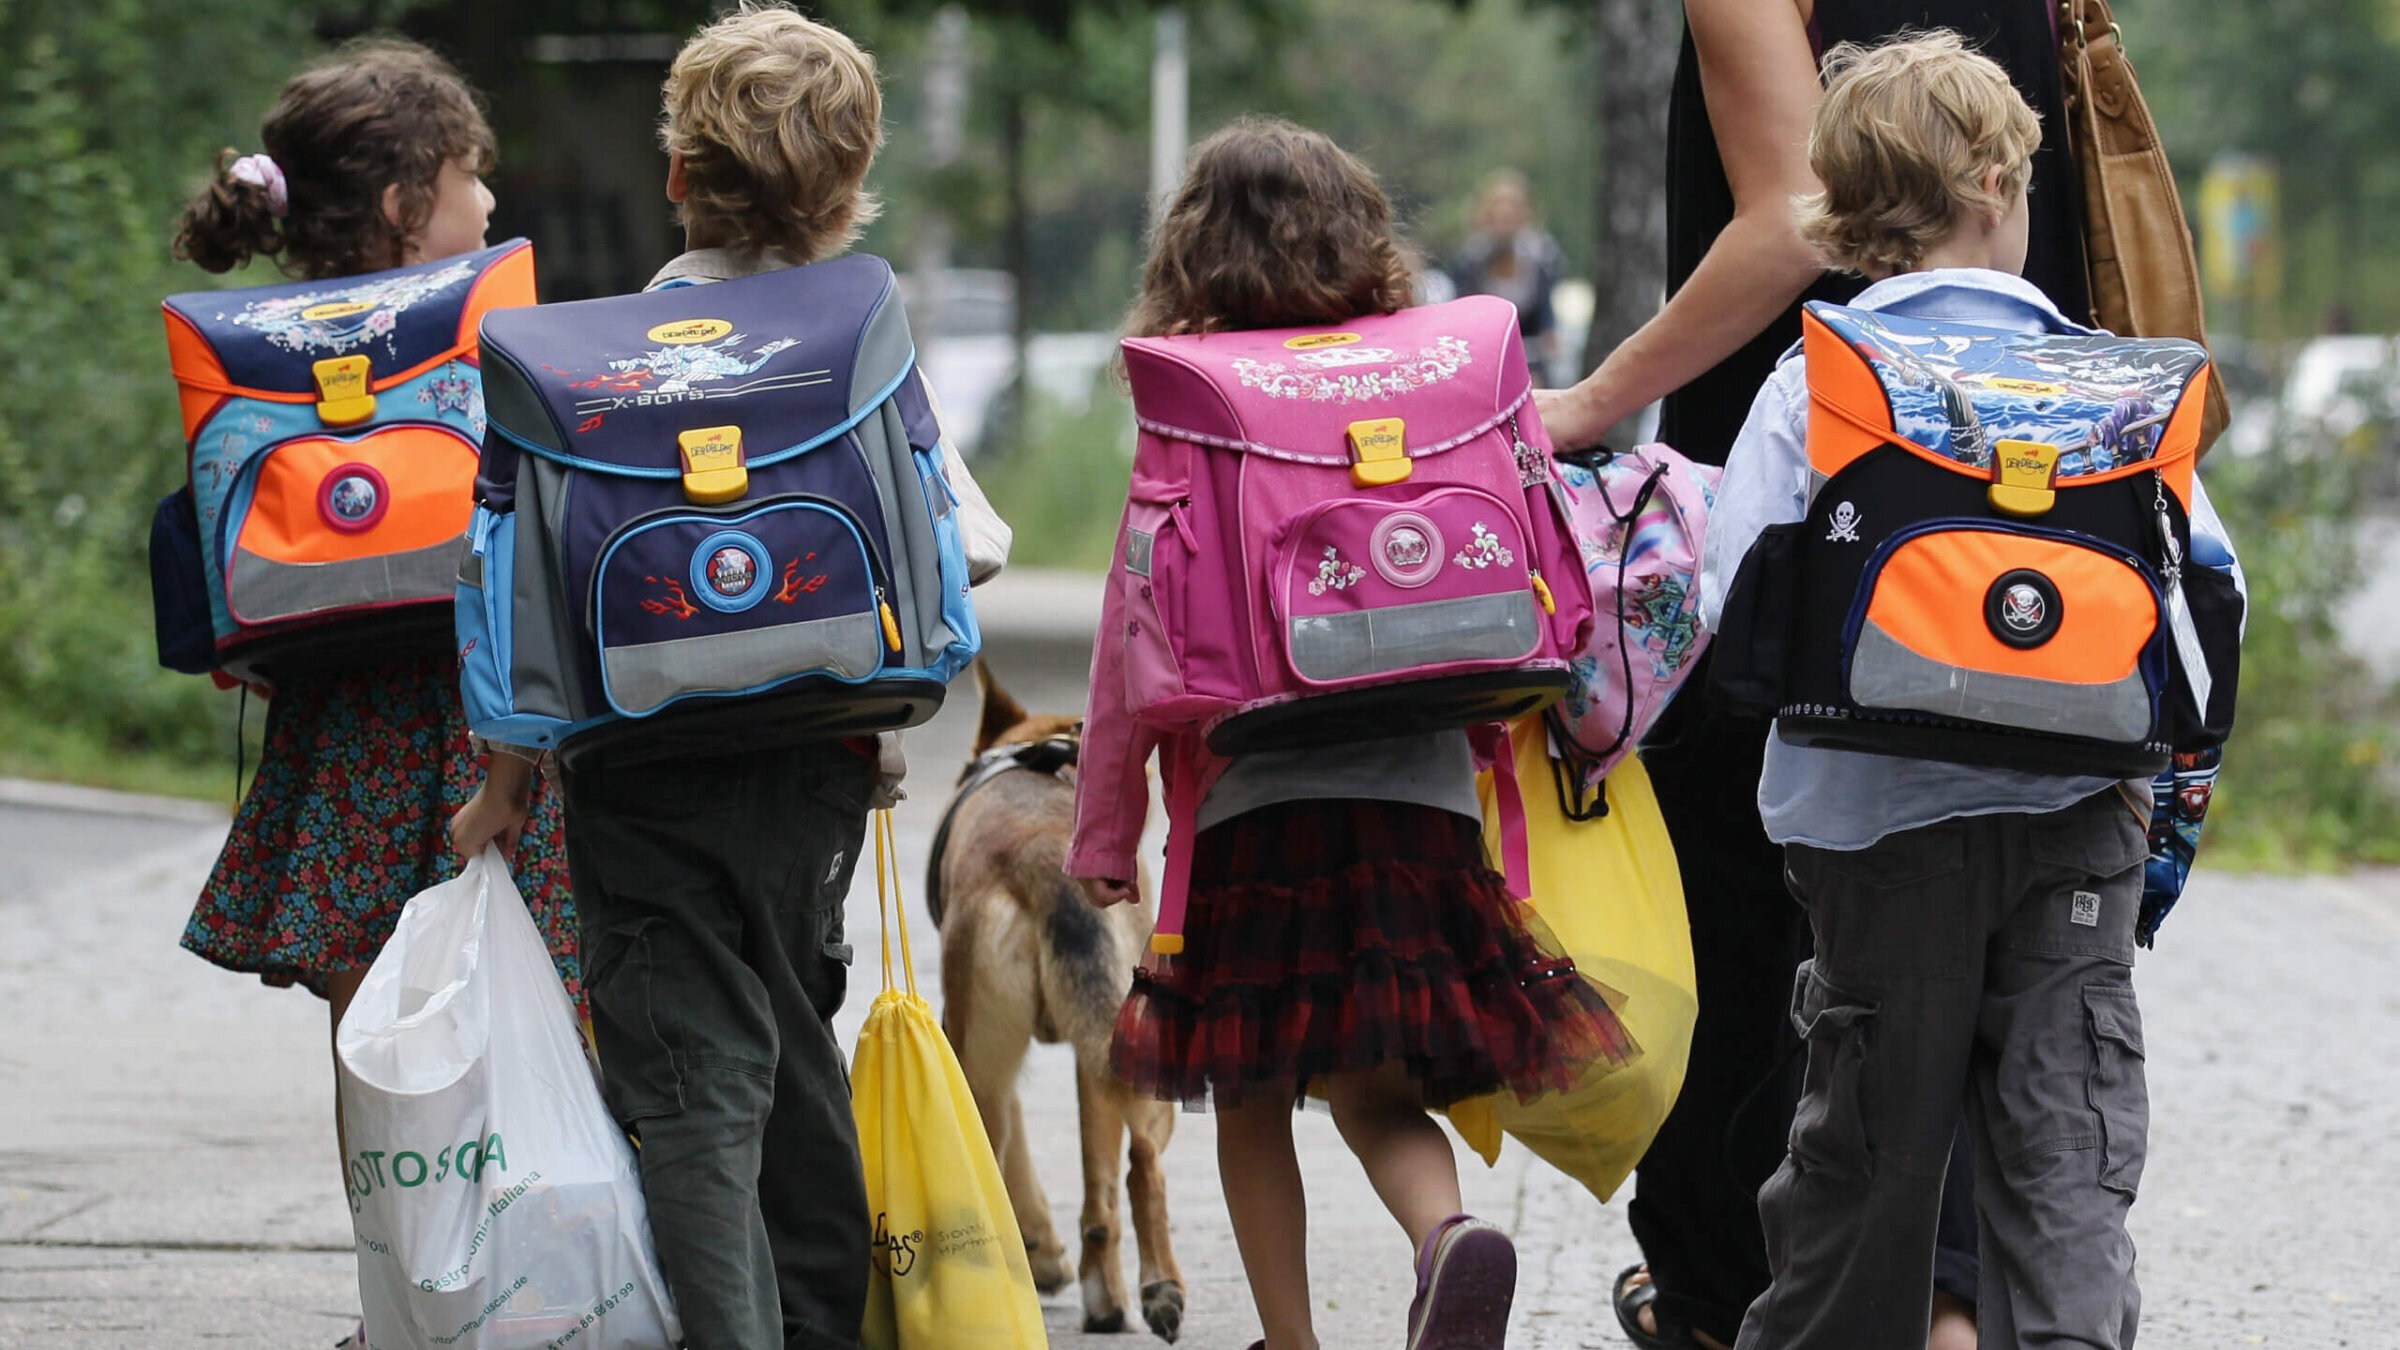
[1111,800,1639,1107]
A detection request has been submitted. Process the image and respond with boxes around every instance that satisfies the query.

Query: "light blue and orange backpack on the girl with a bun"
[151,240,533,677]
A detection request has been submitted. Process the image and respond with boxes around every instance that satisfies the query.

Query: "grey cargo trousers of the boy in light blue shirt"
[1738,790,2150,1350]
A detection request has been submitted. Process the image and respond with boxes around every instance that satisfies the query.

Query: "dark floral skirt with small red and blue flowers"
[182,656,583,1004]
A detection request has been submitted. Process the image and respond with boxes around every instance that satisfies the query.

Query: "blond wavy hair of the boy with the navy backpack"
[658,0,883,262]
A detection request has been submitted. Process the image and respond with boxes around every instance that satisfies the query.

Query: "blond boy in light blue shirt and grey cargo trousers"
[1702,31,2232,1350]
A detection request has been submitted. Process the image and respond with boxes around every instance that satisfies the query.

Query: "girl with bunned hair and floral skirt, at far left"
[173,38,578,1343]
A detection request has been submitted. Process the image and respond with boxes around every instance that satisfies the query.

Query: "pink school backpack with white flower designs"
[1104,295,1594,951]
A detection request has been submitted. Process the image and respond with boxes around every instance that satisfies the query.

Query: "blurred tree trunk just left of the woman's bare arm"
[1584,0,1682,444]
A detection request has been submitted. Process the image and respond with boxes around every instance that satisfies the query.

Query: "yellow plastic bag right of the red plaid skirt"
[1450,718,1699,1201]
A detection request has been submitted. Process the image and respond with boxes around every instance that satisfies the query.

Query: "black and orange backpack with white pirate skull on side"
[1714,303,2242,778]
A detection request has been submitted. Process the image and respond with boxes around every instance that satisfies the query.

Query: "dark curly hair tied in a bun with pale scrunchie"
[173,36,499,281]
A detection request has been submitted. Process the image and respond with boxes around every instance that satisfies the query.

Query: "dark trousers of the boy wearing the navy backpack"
[566,745,874,1350]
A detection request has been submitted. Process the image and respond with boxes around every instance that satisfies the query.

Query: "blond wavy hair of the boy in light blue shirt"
[1793,29,2042,276]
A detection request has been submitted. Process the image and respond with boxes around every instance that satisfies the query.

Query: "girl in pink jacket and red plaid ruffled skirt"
[1068,118,1630,1350]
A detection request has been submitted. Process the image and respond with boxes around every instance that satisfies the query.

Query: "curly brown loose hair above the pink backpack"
[1126,115,1414,336]
